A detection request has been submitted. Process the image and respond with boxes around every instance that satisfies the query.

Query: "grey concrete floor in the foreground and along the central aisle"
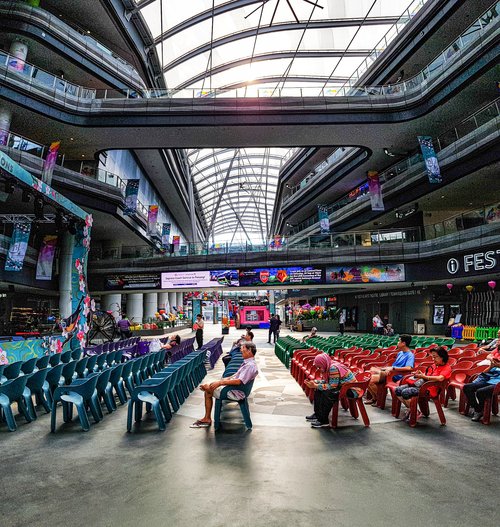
[0,328,500,527]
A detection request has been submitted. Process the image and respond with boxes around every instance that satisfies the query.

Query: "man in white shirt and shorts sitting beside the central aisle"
[191,342,259,428]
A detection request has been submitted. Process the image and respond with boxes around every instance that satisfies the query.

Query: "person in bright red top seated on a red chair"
[395,346,451,421]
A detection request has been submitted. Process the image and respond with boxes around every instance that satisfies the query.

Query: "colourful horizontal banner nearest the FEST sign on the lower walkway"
[326,264,405,284]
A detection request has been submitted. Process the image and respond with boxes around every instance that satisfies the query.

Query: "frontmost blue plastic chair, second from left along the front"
[50,375,100,432]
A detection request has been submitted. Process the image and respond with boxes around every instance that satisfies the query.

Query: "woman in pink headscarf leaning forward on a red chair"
[305,353,361,428]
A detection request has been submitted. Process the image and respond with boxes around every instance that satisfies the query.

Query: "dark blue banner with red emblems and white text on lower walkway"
[240,267,323,287]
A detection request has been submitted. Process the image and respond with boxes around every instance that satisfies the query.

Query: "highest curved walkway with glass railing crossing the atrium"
[0,6,500,150]
